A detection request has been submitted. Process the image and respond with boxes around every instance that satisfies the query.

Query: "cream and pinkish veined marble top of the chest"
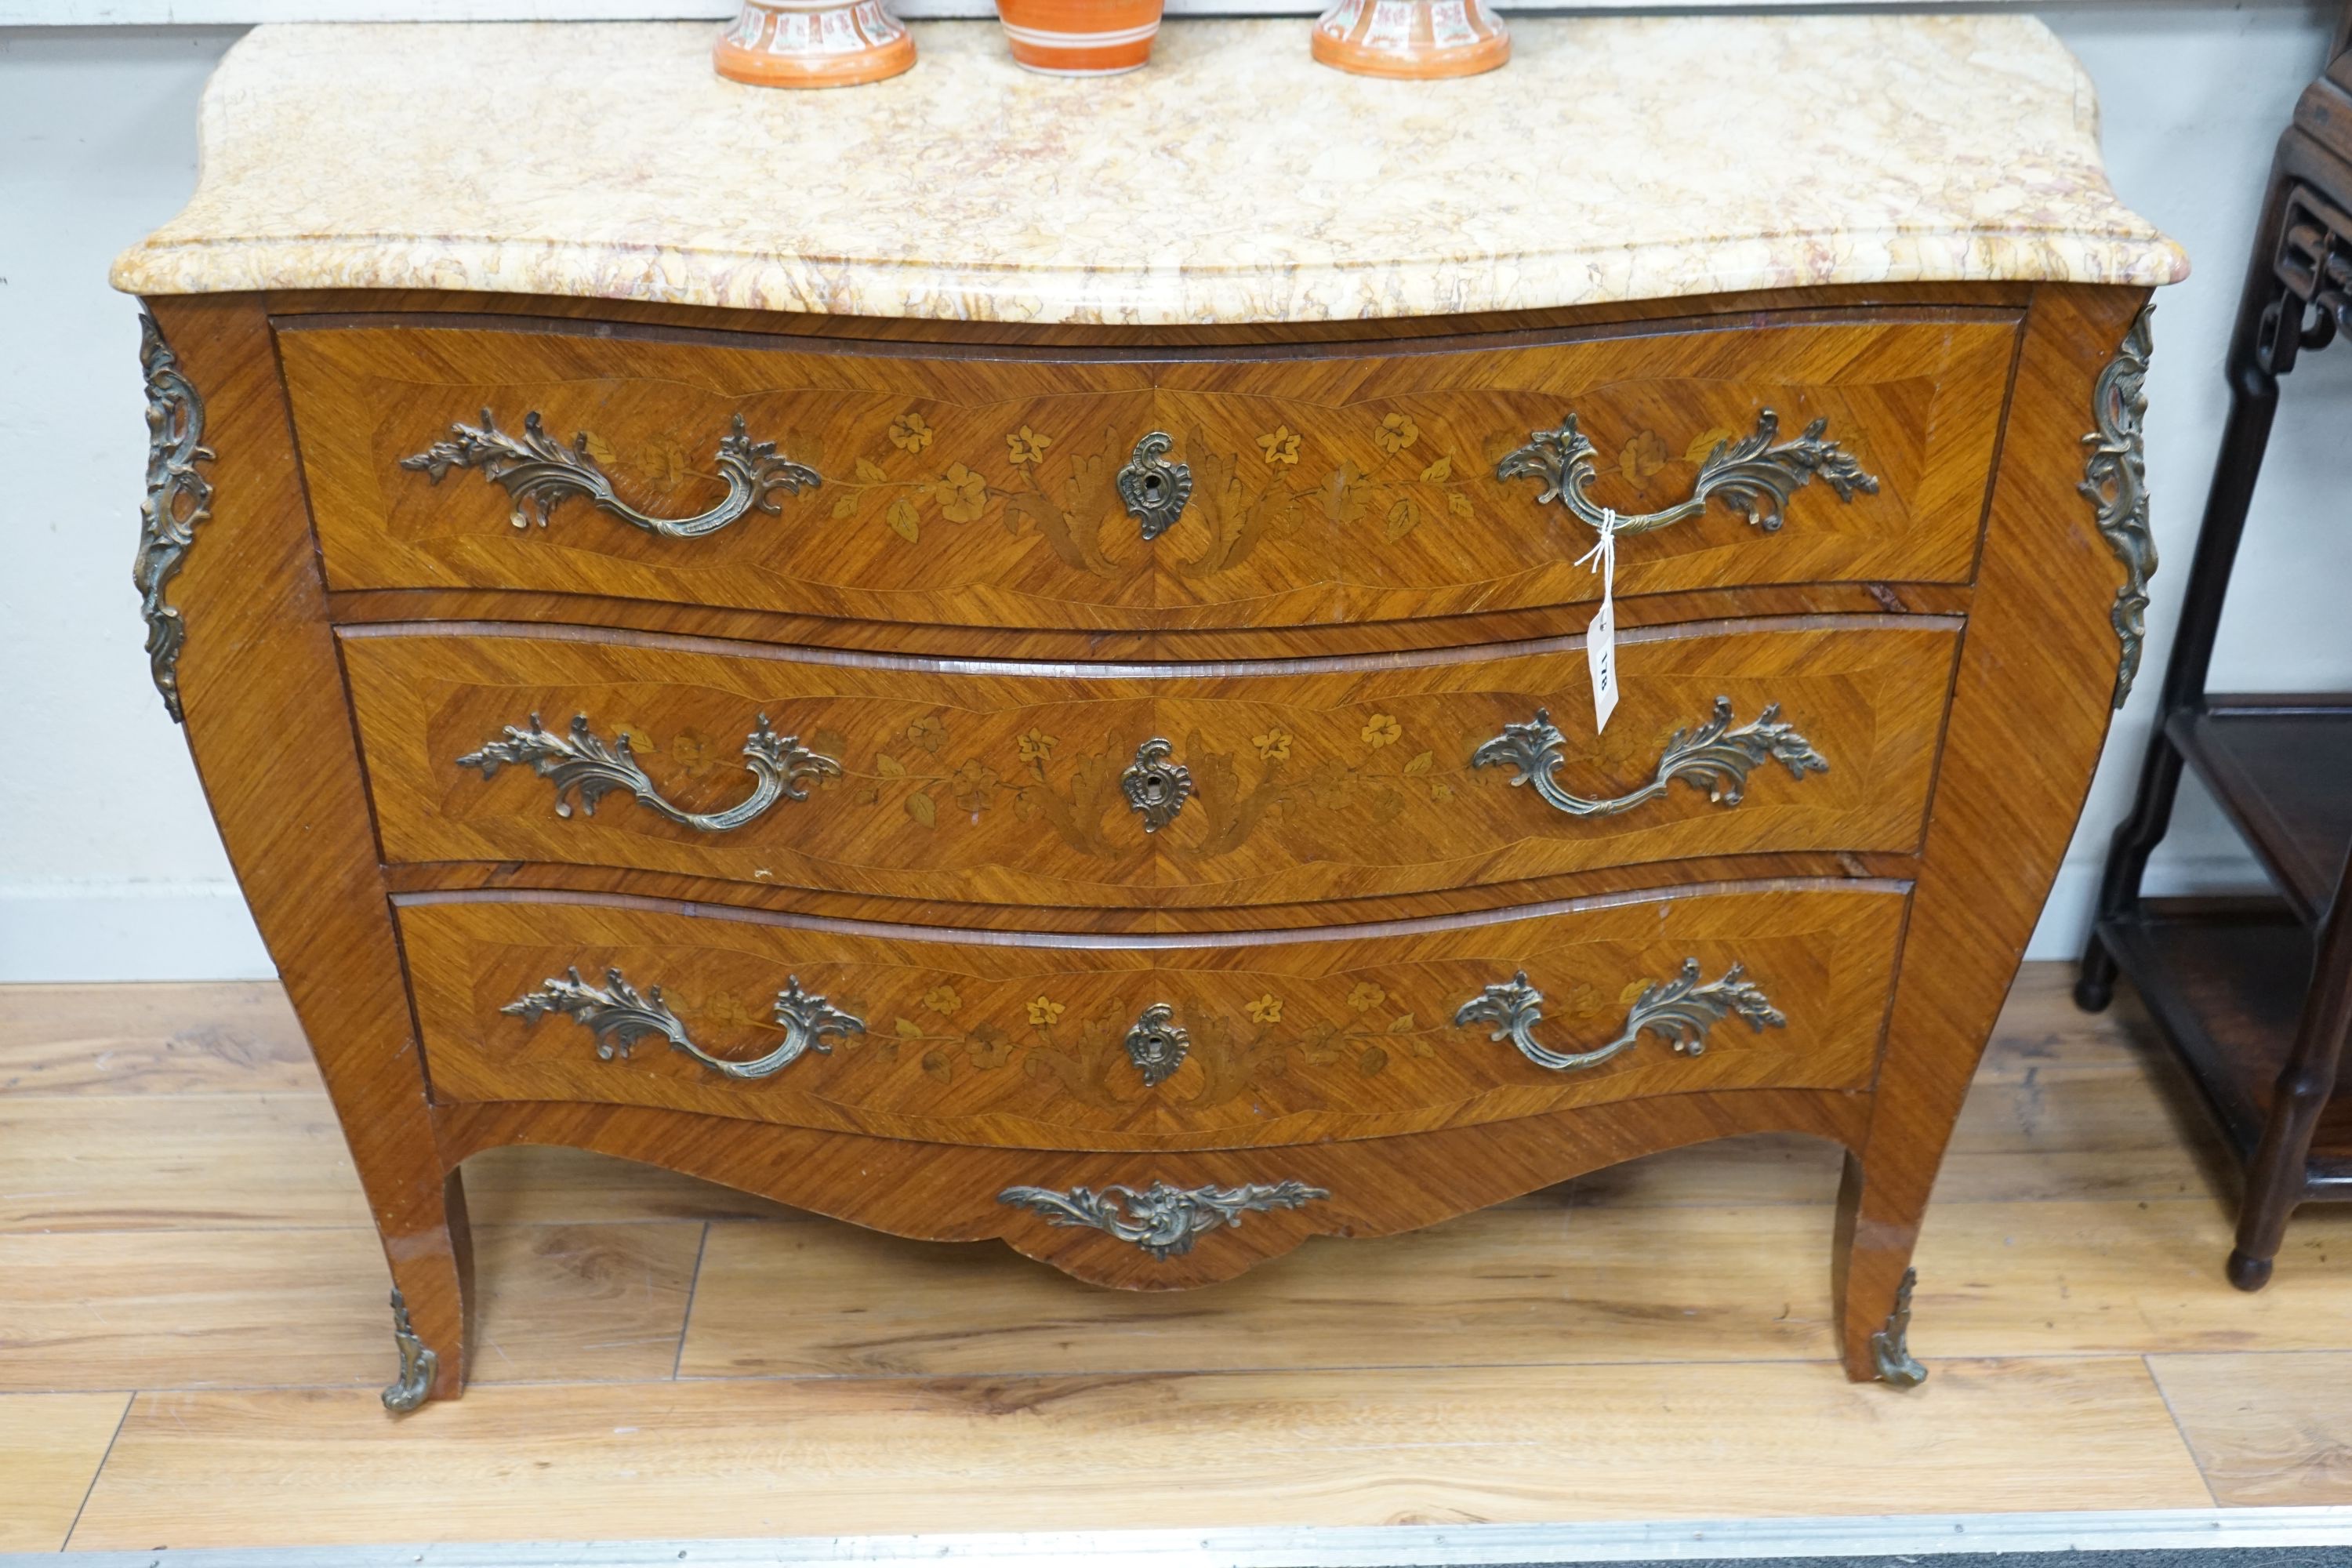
[113,14,2187,325]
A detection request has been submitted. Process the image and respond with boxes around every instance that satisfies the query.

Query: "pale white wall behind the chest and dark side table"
[0,0,2352,980]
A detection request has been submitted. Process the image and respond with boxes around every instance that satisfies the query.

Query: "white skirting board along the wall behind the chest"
[0,858,2260,985]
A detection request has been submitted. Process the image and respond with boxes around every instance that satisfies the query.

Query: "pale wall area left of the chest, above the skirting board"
[0,28,270,980]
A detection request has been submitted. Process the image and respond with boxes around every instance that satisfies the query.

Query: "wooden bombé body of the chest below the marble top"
[118,24,2173,1408]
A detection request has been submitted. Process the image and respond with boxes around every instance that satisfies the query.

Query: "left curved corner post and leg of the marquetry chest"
[139,294,468,1406]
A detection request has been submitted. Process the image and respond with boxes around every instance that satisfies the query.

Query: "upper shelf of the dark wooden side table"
[2164,694,2352,926]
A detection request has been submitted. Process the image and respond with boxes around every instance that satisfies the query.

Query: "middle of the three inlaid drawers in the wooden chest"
[341,616,1959,905]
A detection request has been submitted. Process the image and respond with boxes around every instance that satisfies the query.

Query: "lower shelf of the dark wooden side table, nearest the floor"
[2098,898,2352,1199]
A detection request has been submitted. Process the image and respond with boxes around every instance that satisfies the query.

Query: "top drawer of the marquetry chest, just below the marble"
[280,310,2018,630]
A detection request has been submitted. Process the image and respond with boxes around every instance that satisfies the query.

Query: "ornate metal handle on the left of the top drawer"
[400,409,823,539]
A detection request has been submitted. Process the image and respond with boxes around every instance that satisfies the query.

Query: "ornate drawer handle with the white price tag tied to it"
[1494,409,1879,534]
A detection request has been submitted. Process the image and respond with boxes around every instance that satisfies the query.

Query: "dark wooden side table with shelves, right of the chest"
[2074,7,2352,1290]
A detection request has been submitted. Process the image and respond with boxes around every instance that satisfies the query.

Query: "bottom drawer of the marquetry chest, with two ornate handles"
[400,881,1907,1149]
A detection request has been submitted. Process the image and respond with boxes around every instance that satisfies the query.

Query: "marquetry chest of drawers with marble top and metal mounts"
[118,19,2183,1408]
